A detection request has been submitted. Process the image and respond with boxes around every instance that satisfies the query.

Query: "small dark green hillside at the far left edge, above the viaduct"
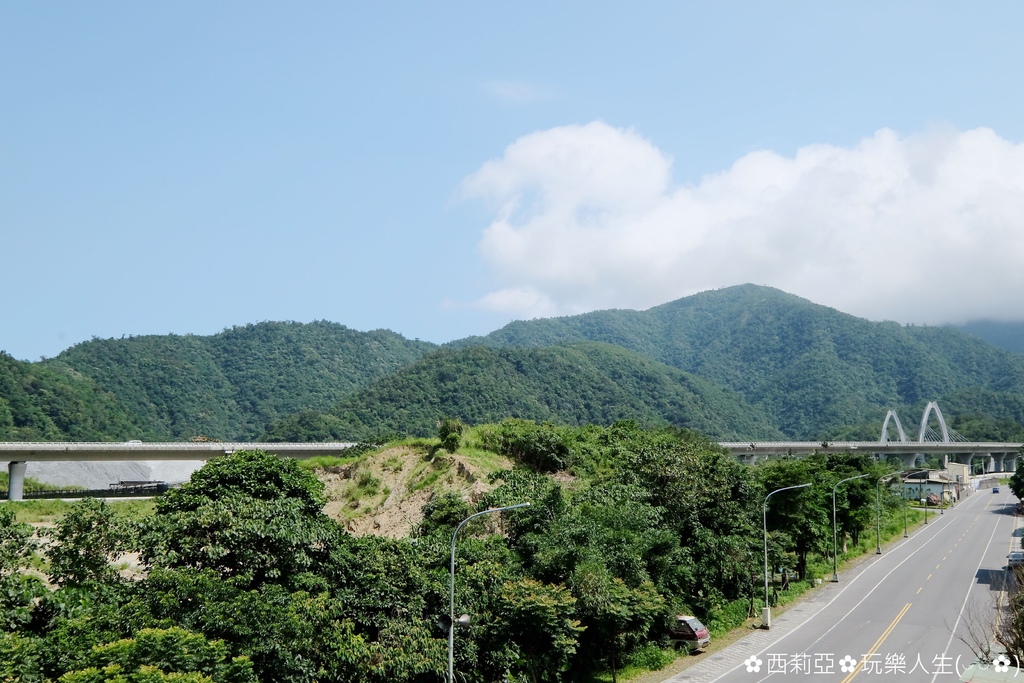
[0,352,146,441]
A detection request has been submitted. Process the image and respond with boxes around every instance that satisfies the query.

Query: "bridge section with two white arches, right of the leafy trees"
[721,400,1024,473]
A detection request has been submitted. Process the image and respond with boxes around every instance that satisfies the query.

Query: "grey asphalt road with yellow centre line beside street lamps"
[668,486,1024,683]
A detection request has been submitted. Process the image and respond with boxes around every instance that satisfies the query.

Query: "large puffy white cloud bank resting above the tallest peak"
[462,122,1024,324]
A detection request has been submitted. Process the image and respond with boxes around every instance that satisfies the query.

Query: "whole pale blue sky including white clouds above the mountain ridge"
[0,2,1024,360]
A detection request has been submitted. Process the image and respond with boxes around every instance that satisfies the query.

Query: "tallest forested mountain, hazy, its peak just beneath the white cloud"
[453,285,1024,438]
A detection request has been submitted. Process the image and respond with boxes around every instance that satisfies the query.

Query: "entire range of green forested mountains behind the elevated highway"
[8,285,1024,440]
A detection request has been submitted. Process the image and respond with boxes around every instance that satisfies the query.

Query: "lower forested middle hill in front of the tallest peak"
[260,342,781,441]
